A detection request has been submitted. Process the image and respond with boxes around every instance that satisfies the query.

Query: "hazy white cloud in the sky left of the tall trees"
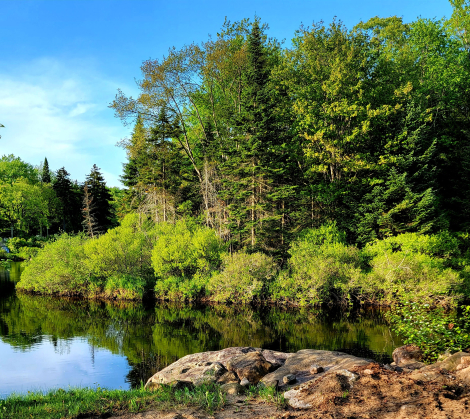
[0,58,134,186]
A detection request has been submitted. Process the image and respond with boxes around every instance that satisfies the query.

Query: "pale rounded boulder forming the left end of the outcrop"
[146,347,280,386]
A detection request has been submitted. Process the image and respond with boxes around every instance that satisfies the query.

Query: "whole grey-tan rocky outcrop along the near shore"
[146,345,470,412]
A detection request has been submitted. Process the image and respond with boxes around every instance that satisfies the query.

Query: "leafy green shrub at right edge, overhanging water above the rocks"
[387,300,470,362]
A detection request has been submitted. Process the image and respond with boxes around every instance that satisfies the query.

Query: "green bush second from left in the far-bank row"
[84,214,155,296]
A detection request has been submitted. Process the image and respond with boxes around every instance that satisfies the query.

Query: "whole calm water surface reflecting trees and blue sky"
[0,263,401,397]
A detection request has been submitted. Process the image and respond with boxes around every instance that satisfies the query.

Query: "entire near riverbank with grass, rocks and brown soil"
[0,346,470,419]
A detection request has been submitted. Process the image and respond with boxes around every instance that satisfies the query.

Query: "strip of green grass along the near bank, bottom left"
[0,384,225,419]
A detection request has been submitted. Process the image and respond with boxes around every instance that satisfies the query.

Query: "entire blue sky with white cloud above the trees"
[0,0,452,186]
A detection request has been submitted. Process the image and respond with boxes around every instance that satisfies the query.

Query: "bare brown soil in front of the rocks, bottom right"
[103,364,470,419]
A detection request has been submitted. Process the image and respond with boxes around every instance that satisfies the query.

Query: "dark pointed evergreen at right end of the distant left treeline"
[84,164,114,232]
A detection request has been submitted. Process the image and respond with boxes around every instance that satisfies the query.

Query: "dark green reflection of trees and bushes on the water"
[0,264,401,392]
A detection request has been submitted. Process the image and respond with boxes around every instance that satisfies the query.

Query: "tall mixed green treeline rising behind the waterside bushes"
[111,2,470,257]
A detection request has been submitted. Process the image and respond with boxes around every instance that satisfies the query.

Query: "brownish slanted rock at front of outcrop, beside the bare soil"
[284,369,359,409]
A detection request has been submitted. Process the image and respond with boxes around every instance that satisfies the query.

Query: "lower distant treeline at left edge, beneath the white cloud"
[0,155,120,241]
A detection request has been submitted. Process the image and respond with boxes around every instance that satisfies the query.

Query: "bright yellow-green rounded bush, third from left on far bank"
[152,220,227,299]
